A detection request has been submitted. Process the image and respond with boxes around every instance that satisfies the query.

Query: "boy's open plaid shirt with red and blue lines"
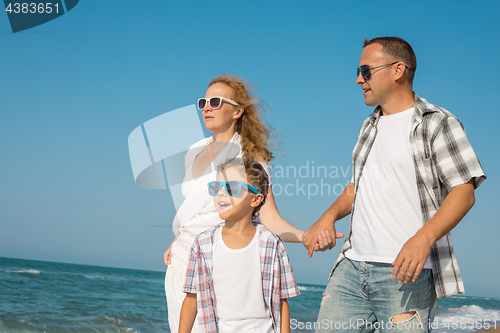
[184,222,300,333]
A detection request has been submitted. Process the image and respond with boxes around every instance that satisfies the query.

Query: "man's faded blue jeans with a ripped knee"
[316,258,437,333]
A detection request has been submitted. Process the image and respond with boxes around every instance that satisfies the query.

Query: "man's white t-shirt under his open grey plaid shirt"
[345,108,432,268]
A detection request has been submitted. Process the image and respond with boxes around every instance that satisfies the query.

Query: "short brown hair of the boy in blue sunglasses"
[217,153,269,219]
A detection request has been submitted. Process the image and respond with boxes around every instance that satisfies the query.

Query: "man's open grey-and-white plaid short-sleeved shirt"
[330,93,486,298]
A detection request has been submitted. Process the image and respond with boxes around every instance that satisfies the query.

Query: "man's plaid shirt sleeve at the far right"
[433,117,486,191]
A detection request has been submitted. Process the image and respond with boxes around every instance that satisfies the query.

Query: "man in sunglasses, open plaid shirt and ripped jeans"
[303,37,486,333]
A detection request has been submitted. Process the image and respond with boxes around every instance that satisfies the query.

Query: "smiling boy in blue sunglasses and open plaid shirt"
[179,157,299,333]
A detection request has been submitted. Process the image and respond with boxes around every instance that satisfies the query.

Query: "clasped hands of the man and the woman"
[302,214,344,258]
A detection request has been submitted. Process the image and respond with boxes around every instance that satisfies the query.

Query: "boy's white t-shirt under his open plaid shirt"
[212,228,274,333]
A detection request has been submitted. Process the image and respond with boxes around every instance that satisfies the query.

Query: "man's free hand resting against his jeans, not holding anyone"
[392,233,433,283]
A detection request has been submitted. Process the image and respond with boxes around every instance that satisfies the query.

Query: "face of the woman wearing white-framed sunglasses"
[202,83,240,134]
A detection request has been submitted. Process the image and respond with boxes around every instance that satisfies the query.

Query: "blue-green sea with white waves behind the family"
[0,258,500,333]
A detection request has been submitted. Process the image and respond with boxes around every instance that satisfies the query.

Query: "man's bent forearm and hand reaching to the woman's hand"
[302,183,354,258]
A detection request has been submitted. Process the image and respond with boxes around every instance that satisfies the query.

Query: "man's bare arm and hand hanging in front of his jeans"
[392,179,475,283]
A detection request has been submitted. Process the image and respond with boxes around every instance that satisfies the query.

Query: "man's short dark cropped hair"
[363,37,417,84]
